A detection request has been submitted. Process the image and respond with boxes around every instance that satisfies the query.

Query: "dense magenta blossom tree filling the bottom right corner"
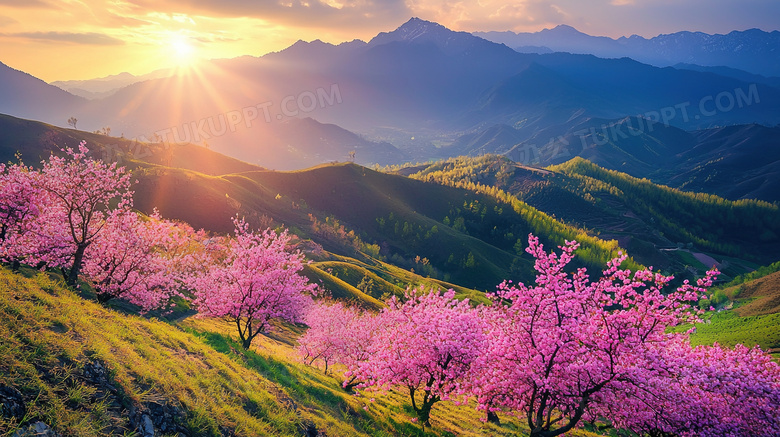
[600,334,780,437]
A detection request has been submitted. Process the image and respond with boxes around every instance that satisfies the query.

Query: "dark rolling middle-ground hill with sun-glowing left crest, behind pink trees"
[0,113,632,292]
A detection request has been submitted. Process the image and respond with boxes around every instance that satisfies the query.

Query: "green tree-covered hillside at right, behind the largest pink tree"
[412,156,780,278]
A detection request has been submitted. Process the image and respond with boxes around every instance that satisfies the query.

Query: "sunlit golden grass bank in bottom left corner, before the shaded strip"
[0,269,297,436]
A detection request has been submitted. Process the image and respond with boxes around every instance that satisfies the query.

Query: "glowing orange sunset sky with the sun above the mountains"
[0,0,780,82]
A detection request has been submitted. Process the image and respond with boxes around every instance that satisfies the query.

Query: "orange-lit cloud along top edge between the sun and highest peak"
[122,0,412,29]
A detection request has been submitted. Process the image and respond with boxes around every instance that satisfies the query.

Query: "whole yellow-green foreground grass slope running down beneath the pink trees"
[0,268,587,437]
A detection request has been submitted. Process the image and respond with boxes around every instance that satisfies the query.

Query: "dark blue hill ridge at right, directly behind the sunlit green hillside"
[448,114,780,202]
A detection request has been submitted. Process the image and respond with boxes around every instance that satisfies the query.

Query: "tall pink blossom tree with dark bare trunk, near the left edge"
[39,141,133,286]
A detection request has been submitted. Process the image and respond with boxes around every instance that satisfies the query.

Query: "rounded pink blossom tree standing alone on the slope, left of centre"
[189,219,316,349]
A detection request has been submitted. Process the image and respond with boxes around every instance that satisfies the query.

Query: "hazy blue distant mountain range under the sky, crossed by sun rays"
[0,18,780,169]
